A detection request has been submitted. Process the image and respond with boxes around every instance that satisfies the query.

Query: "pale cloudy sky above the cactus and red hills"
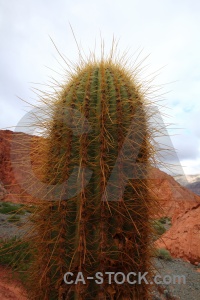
[0,0,200,174]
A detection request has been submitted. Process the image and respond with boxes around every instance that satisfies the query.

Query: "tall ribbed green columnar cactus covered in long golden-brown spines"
[23,52,158,300]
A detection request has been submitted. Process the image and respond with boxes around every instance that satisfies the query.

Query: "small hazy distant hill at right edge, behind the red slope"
[174,174,200,195]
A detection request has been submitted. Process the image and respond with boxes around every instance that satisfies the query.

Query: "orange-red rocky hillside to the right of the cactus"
[152,169,200,263]
